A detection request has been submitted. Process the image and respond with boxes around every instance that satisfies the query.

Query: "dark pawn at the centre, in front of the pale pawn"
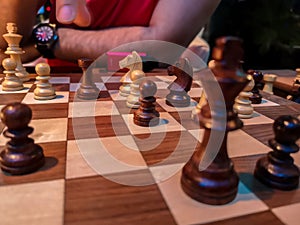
[133,80,159,127]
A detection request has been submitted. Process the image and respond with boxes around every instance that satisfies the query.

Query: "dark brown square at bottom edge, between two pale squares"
[65,171,176,225]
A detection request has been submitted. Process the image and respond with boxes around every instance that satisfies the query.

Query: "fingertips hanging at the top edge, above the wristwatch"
[56,0,91,27]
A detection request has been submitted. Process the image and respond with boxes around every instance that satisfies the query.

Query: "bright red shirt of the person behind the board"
[51,0,159,30]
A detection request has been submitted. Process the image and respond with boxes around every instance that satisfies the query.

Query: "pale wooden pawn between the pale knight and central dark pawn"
[126,70,145,109]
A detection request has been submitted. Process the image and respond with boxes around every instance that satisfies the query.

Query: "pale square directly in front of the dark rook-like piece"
[68,101,119,117]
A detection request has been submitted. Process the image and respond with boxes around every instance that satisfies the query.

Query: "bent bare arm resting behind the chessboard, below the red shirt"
[55,0,220,60]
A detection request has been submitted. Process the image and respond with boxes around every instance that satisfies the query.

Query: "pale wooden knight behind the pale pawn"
[119,51,143,97]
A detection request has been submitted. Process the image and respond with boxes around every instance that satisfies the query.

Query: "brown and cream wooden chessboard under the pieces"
[0,69,300,225]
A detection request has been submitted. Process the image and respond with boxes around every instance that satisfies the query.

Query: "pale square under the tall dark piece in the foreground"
[154,172,268,225]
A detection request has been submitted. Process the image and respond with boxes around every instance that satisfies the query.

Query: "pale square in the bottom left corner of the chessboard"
[0,179,65,225]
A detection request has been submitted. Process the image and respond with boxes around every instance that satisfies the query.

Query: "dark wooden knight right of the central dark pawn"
[166,58,193,107]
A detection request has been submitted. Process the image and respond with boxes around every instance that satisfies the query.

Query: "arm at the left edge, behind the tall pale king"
[0,0,44,63]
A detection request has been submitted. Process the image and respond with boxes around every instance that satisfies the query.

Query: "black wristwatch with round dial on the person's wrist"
[32,23,58,59]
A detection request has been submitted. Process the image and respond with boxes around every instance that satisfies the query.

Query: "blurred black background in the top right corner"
[204,0,300,70]
